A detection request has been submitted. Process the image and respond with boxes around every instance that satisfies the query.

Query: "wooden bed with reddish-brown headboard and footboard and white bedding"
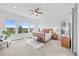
[33,29,53,43]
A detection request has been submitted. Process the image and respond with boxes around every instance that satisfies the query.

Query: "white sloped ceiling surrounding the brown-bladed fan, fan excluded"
[0,3,73,24]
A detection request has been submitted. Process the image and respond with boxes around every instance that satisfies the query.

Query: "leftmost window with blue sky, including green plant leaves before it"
[2,19,16,37]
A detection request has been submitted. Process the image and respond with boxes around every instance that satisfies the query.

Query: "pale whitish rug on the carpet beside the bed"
[26,39,44,49]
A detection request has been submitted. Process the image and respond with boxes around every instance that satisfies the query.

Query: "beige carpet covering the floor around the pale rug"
[0,39,73,56]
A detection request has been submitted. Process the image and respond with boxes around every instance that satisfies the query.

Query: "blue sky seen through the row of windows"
[5,19,34,28]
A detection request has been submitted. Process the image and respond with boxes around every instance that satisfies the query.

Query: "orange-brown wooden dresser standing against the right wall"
[61,36,71,48]
